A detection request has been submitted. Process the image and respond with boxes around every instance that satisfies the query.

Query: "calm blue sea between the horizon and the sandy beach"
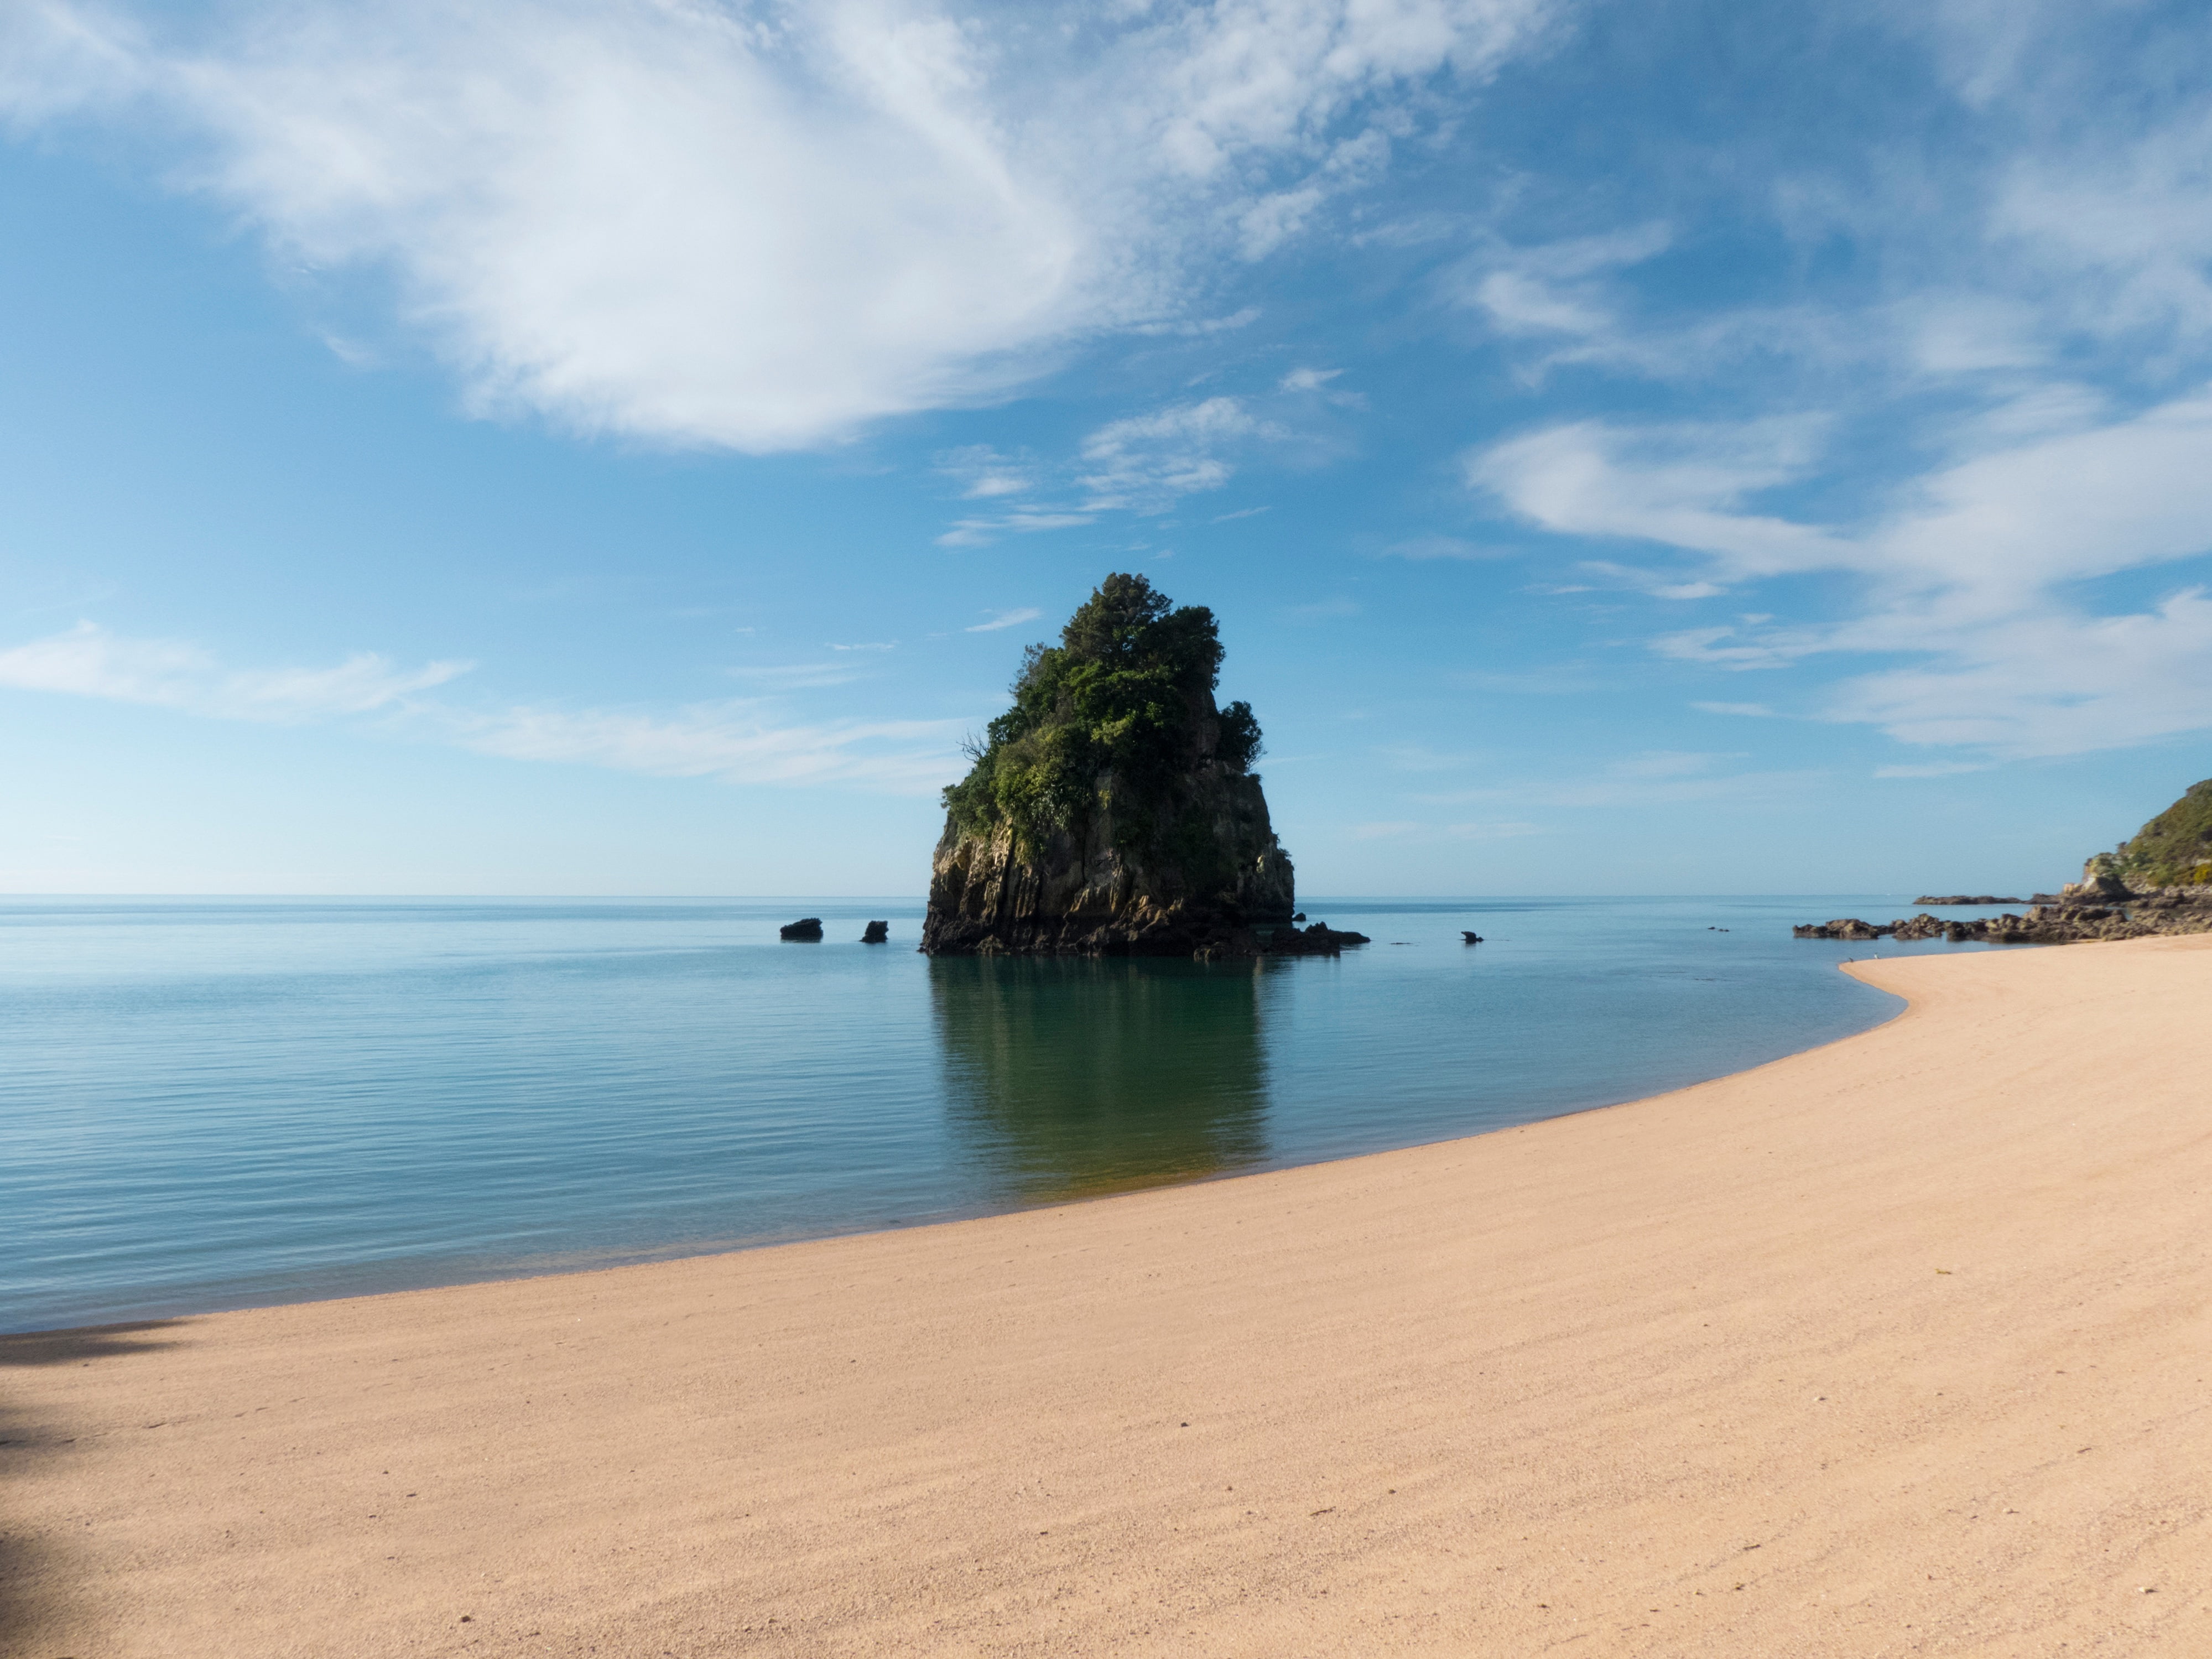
[0,896,2026,1329]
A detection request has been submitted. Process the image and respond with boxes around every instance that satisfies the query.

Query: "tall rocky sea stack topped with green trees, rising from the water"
[923,575,1292,958]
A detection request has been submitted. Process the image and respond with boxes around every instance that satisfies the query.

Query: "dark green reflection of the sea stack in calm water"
[929,955,1267,1201]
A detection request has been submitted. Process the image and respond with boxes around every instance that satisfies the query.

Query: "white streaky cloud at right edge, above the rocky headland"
[1469,396,2212,755]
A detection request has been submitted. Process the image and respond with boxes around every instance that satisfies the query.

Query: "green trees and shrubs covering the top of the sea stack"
[945,573,1261,854]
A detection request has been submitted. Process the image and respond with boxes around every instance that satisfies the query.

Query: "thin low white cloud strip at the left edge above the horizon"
[0,622,471,724]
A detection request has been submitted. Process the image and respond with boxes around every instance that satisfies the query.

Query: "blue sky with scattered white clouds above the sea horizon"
[0,0,2212,896]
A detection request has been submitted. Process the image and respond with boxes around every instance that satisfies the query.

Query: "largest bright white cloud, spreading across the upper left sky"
[0,0,1550,451]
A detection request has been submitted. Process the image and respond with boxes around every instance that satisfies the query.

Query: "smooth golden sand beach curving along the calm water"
[0,938,2212,1659]
